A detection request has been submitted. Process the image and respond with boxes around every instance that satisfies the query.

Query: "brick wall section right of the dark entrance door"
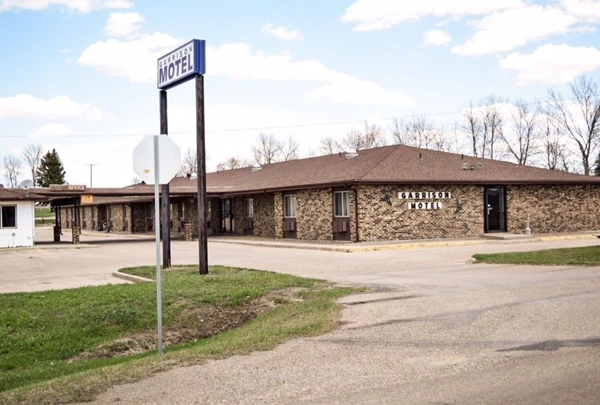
[506,185,600,233]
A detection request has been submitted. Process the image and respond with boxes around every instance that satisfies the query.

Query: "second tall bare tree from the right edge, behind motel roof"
[500,100,541,165]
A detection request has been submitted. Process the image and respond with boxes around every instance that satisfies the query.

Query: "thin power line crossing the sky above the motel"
[0,98,575,138]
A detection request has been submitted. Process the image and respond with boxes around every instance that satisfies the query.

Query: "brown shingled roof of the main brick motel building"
[204,145,600,194]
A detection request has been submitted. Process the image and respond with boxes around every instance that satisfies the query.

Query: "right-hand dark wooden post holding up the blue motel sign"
[196,75,208,274]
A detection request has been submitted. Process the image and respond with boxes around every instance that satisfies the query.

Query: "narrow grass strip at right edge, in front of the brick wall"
[473,246,600,266]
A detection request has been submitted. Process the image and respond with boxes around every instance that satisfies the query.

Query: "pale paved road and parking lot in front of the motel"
[0,229,600,404]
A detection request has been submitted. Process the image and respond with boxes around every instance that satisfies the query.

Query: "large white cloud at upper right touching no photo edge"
[452,5,577,56]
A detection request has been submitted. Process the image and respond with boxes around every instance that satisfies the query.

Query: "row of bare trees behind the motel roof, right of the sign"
[207,76,600,175]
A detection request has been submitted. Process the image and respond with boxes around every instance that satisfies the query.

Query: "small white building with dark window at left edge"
[0,184,45,249]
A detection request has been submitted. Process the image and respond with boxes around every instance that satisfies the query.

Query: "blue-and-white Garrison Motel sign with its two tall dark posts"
[156,39,208,274]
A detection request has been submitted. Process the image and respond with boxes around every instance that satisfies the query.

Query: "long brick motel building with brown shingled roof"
[36,145,600,242]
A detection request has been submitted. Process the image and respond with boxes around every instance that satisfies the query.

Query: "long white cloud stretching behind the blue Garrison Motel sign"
[79,37,413,106]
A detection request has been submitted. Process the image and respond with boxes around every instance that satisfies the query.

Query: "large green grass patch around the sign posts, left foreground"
[0,267,357,404]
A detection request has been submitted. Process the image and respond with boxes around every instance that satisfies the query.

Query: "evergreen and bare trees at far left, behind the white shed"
[2,143,66,188]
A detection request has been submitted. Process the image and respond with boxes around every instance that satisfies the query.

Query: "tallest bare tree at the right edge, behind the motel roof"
[547,76,600,175]
